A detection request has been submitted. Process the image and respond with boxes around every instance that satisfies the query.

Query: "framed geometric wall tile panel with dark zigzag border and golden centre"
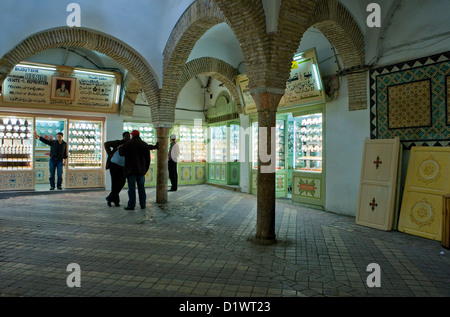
[370,52,450,148]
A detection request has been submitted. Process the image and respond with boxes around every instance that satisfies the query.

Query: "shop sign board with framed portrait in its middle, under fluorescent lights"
[0,63,121,113]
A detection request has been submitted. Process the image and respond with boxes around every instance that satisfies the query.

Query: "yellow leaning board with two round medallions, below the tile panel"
[398,147,450,241]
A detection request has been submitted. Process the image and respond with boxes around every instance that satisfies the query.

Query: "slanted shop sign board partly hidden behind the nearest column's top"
[236,49,325,114]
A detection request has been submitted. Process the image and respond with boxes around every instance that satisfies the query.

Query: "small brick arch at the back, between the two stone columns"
[179,57,243,113]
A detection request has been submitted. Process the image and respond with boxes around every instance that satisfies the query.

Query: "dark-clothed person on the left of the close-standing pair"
[104,132,130,207]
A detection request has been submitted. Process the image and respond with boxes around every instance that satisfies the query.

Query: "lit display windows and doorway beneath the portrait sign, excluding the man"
[0,113,105,190]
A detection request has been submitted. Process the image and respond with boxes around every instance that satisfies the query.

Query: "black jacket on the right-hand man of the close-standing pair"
[119,137,150,176]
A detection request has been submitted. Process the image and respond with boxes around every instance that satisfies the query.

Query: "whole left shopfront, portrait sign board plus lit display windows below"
[0,63,121,190]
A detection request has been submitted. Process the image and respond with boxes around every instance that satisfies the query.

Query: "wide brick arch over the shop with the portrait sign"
[0,27,160,121]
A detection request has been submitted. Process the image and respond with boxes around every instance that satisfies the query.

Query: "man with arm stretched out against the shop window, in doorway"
[34,132,68,190]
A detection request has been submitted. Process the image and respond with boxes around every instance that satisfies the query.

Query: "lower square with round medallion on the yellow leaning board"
[398,191,444,241]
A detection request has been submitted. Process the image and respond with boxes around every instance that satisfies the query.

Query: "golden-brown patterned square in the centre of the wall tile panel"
[388,80,431,129]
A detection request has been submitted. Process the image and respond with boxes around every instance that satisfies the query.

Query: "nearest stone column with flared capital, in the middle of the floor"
[252,87,284,244]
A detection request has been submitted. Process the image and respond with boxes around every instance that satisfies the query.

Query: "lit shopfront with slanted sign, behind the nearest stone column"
[237,49,326,209]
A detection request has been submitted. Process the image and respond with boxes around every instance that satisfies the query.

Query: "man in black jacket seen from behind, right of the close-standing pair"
[119,130,150,210]
